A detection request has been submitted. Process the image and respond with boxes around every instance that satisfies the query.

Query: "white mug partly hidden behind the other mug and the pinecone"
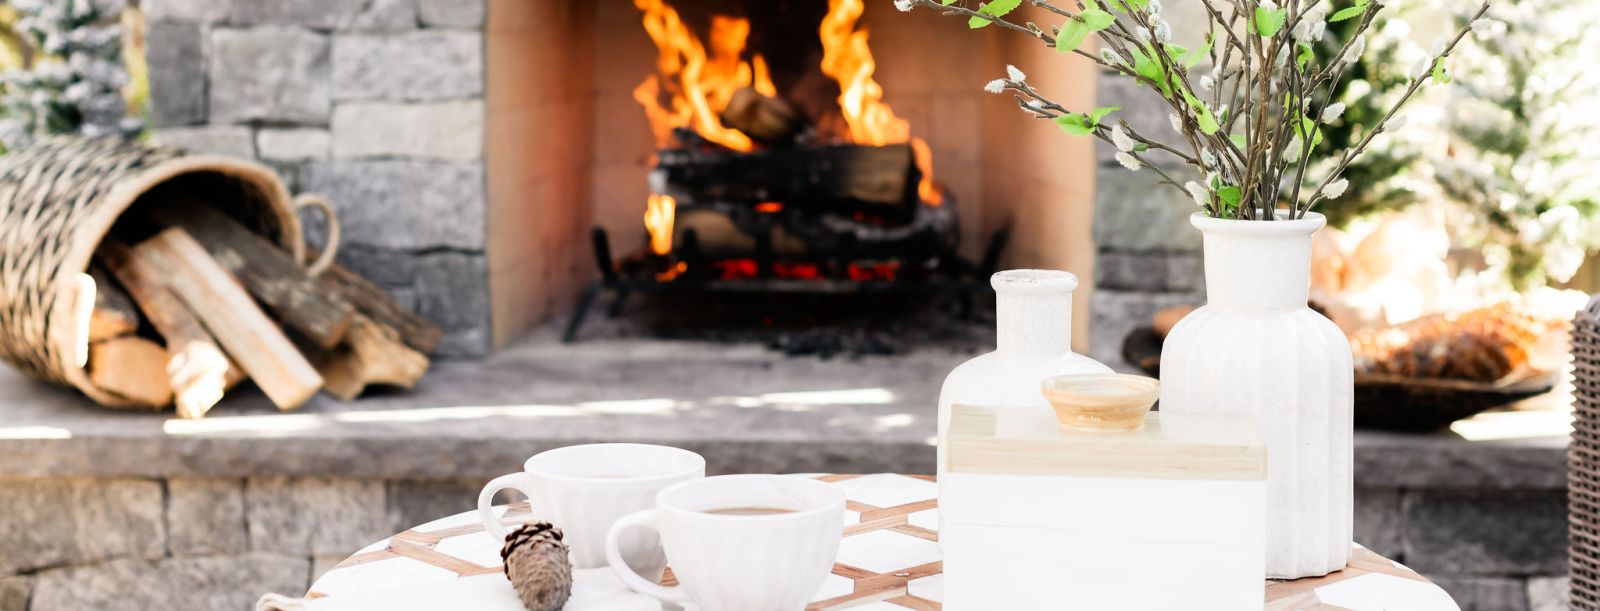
[478,443,706,579]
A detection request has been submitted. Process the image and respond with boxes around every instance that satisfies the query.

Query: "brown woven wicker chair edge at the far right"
[1566,296,1600,609]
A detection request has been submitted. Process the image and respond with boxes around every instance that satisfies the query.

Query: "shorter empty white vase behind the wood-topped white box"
[936,269,1110,494]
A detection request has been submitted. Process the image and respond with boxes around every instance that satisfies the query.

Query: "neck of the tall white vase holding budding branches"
[1195,216,1325,310]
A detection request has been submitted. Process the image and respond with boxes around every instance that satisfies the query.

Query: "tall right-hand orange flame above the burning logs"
[818,0,942,205]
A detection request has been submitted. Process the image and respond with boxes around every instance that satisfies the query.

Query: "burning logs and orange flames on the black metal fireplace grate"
[565,0,1006,341]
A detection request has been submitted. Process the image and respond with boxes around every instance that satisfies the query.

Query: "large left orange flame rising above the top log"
[634,0,778,150]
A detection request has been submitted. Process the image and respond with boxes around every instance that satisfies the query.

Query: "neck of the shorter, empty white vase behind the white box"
[990,270,1078,357]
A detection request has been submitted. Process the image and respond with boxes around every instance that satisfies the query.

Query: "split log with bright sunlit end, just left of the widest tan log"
[96,237,245,417]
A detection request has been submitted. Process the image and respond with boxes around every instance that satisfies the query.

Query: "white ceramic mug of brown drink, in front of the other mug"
[605,475,845,611]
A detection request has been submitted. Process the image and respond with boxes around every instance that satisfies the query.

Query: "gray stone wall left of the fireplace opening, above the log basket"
[142,0,490,355]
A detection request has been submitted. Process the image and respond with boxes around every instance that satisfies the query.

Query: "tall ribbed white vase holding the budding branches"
[1160,213,1355,579]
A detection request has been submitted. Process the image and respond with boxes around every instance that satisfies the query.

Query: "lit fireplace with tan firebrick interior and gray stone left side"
[149,0,1096,355]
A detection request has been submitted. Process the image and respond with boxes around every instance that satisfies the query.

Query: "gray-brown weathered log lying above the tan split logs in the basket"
[147,195,355,349]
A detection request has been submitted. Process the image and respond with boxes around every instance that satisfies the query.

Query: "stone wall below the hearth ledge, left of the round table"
[0,478,483,611]
